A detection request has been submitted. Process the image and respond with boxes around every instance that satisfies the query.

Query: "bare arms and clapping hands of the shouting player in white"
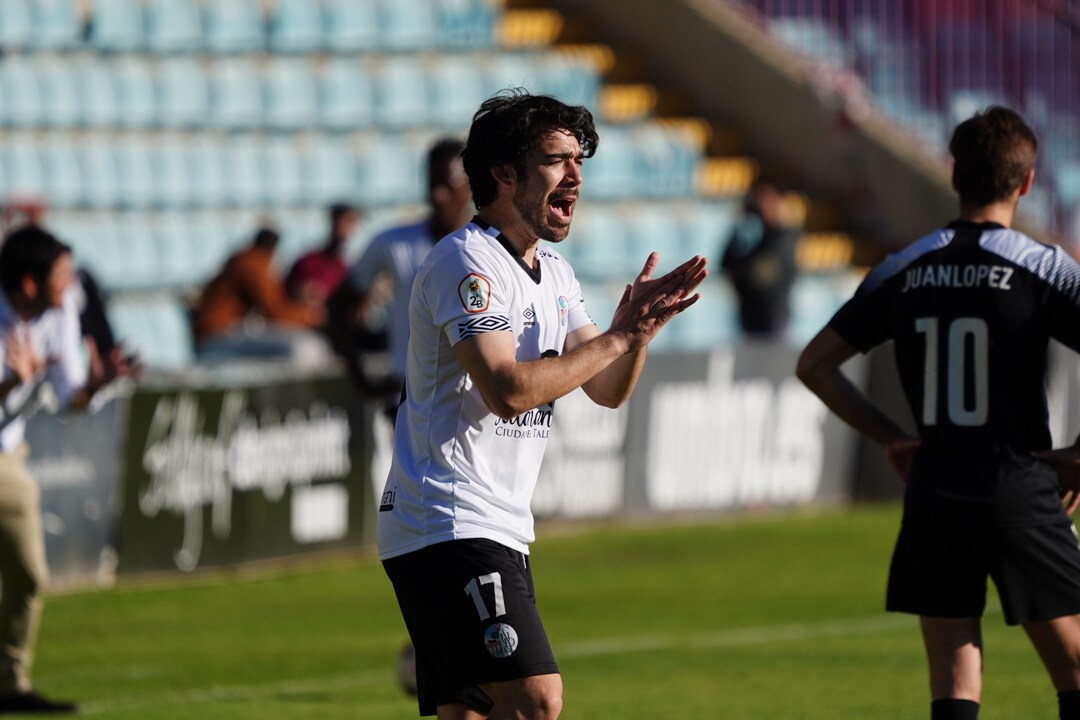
[454,253,706,419]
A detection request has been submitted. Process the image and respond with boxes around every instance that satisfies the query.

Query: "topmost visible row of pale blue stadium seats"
[0,0,500,53]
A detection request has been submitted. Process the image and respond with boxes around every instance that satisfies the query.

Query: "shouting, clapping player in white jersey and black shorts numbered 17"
[378,90,706,720]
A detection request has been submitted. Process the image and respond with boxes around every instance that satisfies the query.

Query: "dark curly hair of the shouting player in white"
[461,87,599,207]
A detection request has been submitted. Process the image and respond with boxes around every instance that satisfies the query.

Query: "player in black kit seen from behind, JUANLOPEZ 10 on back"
[797,107,1080,720]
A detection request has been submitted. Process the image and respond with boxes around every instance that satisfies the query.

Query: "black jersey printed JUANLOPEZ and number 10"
[829,221,1080,518]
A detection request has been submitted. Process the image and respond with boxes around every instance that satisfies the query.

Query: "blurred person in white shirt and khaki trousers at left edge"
[0,226,135,714]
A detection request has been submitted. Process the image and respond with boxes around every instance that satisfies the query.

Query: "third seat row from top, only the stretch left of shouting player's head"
[0,133,431,209]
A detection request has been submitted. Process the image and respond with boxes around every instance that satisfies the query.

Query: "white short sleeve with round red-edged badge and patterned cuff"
[421,249,512,345]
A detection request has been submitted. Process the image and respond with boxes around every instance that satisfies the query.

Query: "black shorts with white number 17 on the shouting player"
[382,540,558,716]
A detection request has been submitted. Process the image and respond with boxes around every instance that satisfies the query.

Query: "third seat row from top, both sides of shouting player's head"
[0,124,702,209]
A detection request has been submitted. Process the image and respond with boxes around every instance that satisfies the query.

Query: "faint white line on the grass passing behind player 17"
[80,615,916,715]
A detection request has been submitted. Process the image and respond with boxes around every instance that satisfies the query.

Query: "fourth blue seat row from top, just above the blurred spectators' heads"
[50,201,738,294]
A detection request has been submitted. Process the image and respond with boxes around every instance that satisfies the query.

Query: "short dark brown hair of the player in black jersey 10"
[948,106,1039,206]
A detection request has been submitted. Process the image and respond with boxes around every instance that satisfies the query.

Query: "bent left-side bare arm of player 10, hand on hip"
[795,326,919,479]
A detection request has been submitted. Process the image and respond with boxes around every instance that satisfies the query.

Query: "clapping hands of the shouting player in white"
[611,253,708,350]
